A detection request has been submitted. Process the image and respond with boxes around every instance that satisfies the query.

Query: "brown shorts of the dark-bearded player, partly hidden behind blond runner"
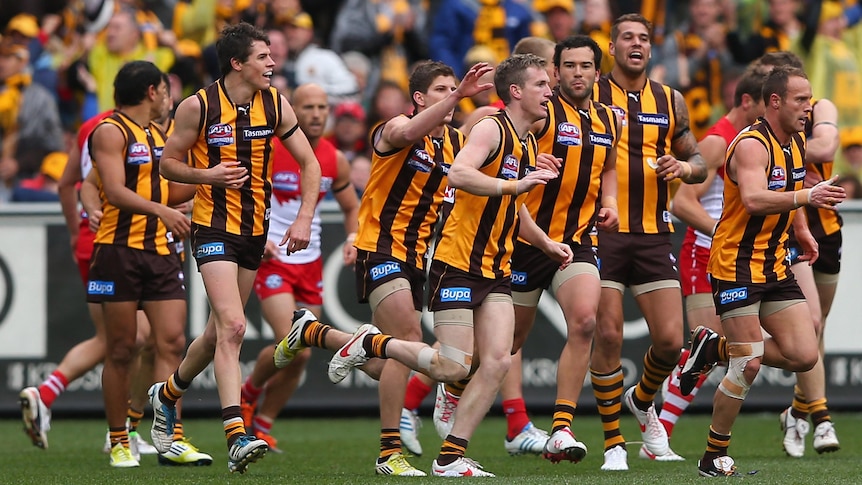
[512,241,599,292]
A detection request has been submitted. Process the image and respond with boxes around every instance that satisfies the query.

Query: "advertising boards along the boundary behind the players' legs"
[0,202,862,416]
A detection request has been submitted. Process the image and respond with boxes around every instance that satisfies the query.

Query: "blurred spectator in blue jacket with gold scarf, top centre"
[428,0,534,78]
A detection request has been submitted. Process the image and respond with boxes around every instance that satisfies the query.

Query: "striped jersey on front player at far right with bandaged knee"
[707,120,805,283]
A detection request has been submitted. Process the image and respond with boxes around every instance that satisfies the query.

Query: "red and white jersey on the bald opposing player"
[267,138,338,264]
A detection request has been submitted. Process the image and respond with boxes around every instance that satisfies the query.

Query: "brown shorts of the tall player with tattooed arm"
[598,232,679,287]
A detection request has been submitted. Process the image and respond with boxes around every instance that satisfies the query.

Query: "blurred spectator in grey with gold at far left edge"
[0,43,63,199]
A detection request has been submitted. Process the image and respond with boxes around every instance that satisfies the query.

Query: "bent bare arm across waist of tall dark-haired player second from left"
[159,96,248,189]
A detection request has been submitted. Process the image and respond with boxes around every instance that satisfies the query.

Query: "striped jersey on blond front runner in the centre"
[434,110,538,279]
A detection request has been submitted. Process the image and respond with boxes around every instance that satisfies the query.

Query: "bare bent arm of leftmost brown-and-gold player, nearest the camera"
[90,124,191,238]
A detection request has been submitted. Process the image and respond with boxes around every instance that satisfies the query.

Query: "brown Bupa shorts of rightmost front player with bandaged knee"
[710,273,805,315]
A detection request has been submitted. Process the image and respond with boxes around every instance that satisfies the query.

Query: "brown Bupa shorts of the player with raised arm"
[353,249,425,311]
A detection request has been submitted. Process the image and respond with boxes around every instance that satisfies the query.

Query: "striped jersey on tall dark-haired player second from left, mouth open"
[189,79,282,236]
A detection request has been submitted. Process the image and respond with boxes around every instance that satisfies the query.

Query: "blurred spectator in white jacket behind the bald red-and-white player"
[284,12,358,104]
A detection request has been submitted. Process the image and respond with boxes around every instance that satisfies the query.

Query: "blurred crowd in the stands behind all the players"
[0,0,862,203]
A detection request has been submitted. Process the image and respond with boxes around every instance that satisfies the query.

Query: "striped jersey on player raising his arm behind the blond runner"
[354,118,464,268]
